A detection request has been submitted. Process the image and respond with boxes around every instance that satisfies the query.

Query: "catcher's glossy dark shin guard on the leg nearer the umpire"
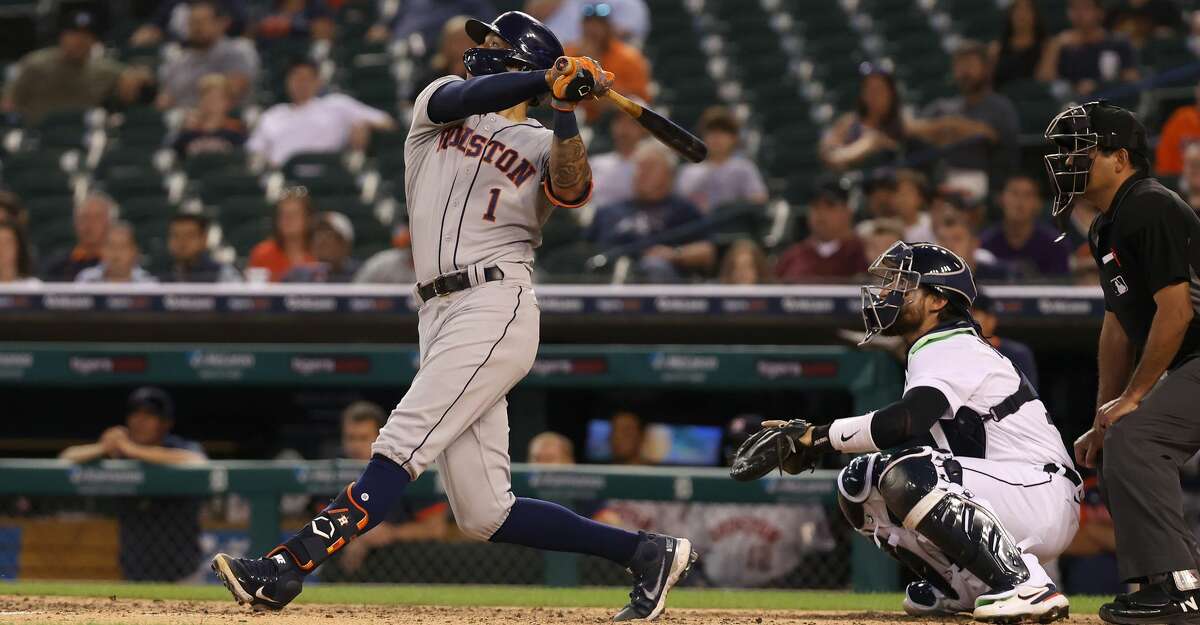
[880,449,1030,590]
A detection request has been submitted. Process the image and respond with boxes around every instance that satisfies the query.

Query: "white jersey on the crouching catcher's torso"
[905,326,1074,467]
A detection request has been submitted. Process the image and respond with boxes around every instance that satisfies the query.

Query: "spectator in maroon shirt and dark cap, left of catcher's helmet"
[775,178,866,283]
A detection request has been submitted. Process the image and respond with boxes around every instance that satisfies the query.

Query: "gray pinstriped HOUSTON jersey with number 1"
[404,76,553,282]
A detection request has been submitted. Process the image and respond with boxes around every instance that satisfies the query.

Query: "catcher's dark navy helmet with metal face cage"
[859,241,978,344]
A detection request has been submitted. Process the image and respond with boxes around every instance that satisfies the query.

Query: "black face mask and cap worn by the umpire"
[1045,101,1150,217]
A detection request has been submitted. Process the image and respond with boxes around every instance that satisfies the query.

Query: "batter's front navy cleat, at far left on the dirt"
[212,553,304,609]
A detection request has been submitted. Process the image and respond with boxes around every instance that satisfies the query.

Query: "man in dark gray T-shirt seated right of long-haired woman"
[907,41,1021,198]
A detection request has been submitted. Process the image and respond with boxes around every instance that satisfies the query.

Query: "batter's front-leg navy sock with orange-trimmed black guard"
[266,453,412,573]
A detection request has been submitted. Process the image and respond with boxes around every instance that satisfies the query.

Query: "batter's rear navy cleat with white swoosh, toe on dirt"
[612,534,700,620]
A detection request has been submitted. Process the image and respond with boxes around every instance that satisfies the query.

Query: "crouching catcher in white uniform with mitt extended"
[731,241,1081,623]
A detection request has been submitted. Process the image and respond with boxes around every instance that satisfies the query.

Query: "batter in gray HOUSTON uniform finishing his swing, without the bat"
[212,11,696,620]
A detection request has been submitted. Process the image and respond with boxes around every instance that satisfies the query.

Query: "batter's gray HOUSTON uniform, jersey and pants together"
[372,77,552,540]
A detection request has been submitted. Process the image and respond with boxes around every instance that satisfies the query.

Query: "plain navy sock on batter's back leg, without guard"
[491,497,641,566]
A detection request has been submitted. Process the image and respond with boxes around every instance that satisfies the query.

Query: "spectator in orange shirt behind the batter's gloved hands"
[564,2,650,121]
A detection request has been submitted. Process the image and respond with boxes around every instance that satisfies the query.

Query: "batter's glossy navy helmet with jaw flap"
[462,11,563,76]
